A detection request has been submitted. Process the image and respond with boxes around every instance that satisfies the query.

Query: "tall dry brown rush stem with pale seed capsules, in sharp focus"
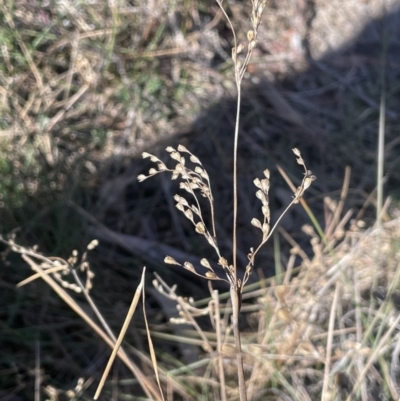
[138,0,316,401]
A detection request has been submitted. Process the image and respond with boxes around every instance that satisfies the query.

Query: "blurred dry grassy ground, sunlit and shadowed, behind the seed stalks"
[0,0,400,401]
